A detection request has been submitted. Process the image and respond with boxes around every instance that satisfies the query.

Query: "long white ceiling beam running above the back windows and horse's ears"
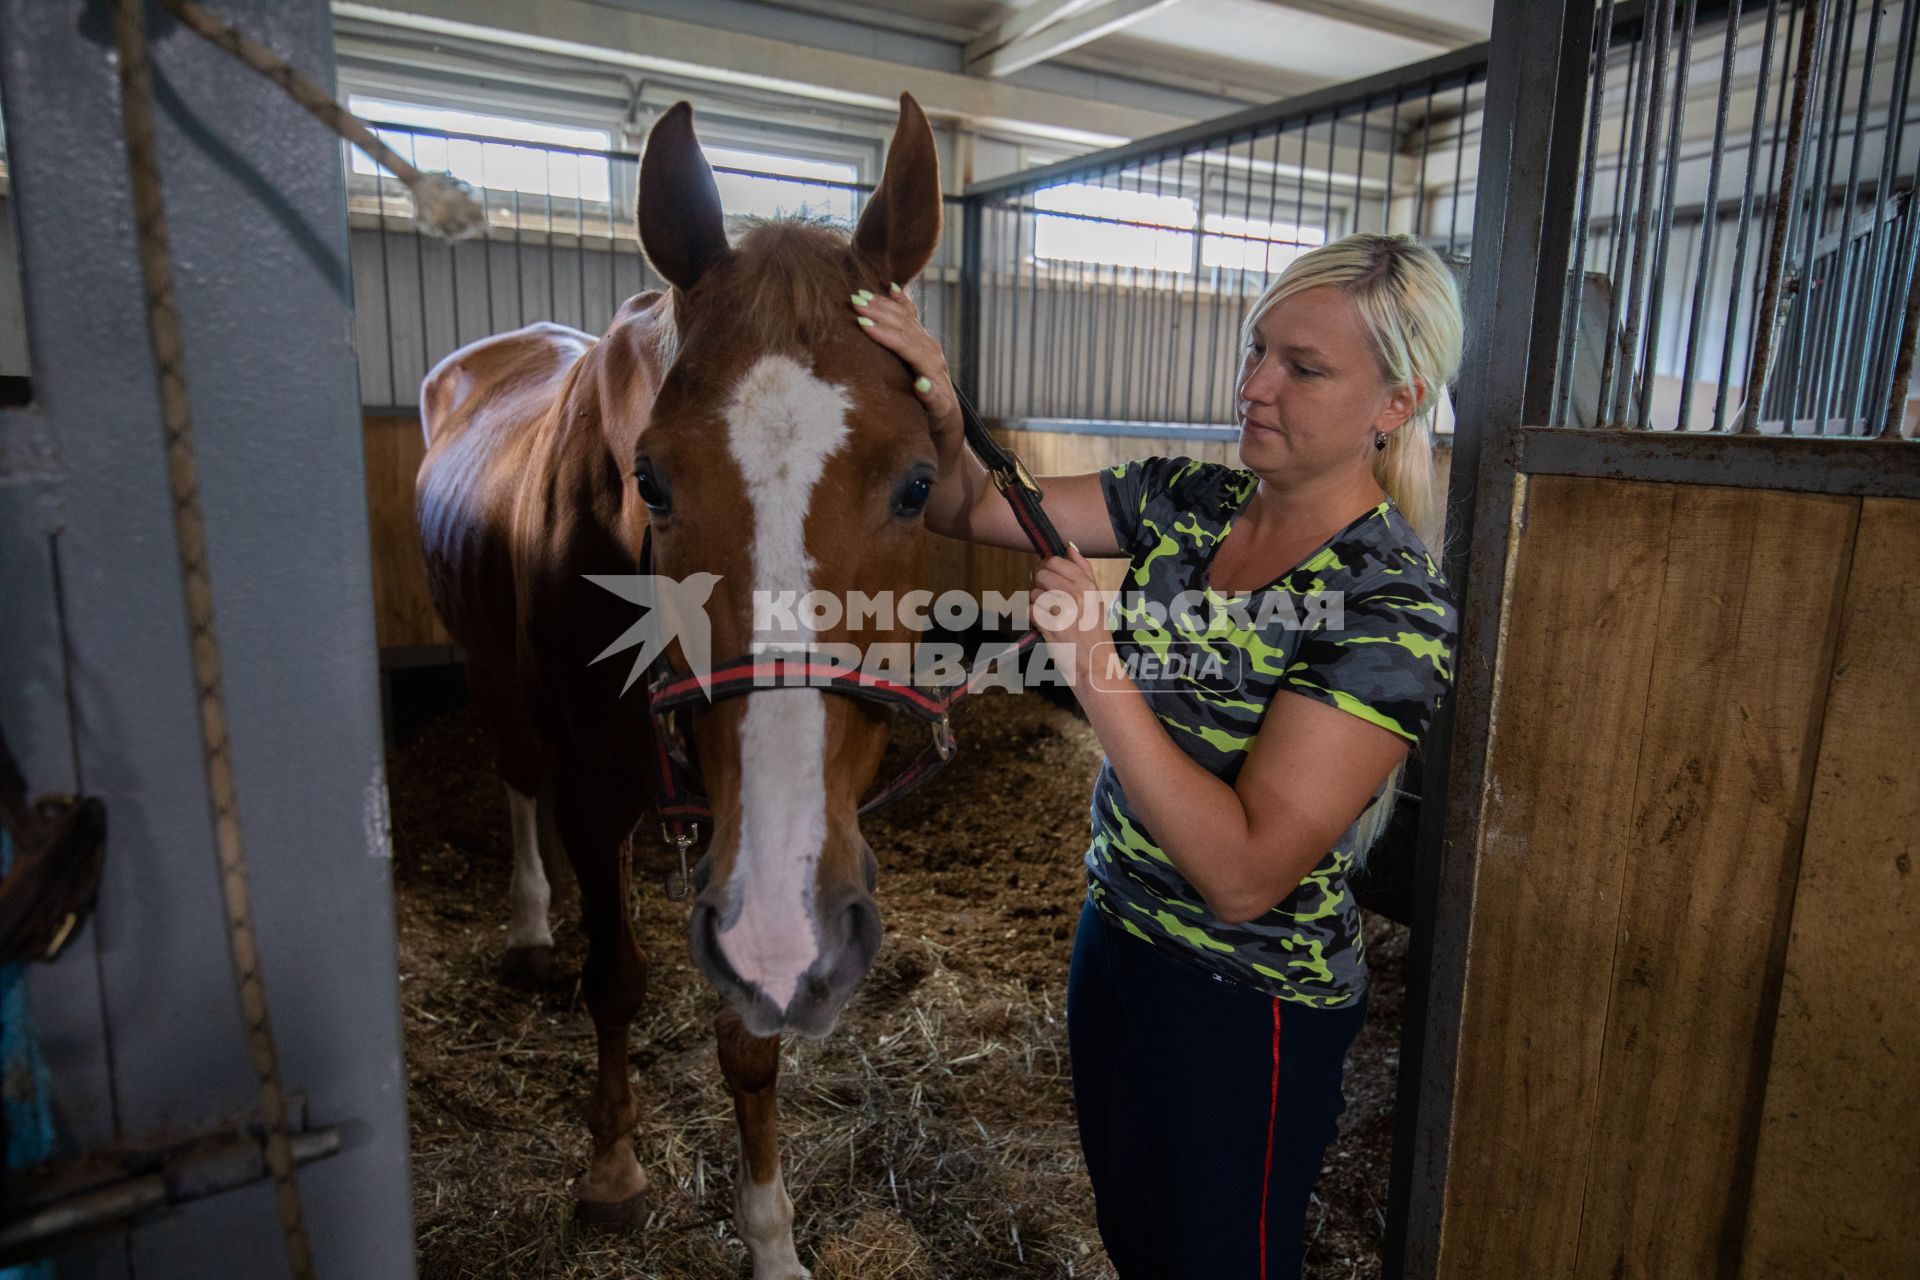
[332,0,1190,146]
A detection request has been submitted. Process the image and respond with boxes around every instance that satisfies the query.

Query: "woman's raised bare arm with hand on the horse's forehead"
[854,292,1121,557]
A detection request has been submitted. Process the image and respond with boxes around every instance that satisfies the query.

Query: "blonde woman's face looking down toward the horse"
[1238,286,1415,476]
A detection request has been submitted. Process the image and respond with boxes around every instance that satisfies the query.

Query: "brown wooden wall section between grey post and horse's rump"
[361,416,453,649]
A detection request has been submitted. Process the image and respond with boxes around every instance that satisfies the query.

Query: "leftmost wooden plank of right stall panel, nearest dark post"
[1436,476,1678,1278]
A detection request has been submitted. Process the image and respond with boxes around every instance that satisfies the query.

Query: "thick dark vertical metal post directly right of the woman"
[1382,0,1594,1280]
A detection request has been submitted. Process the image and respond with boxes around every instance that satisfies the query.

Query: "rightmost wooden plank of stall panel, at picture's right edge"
[1740,499,1920,1280]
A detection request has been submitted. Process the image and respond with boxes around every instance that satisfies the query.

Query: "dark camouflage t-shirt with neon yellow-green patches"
[1087,459,1457,1007]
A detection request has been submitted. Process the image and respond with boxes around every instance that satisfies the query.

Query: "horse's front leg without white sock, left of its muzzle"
[553,766,647,1228]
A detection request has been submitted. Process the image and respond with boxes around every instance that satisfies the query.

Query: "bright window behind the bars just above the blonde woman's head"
[1033,182,1327,274]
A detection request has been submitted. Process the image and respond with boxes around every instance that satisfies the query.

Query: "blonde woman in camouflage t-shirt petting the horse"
[854,234,1461,1280]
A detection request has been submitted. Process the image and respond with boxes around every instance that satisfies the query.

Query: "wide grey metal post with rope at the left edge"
[0,0,413,1280]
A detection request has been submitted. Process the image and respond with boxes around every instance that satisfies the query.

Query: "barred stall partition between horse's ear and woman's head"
[960,46,1486,430]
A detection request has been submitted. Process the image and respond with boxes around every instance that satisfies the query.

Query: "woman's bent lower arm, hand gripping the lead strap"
[1033,555,1407,925]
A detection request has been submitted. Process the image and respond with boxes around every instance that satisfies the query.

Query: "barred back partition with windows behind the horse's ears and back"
[344,123,964,410]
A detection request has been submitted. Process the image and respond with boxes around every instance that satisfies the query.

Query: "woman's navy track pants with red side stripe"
[1068,902,1367,1280]
